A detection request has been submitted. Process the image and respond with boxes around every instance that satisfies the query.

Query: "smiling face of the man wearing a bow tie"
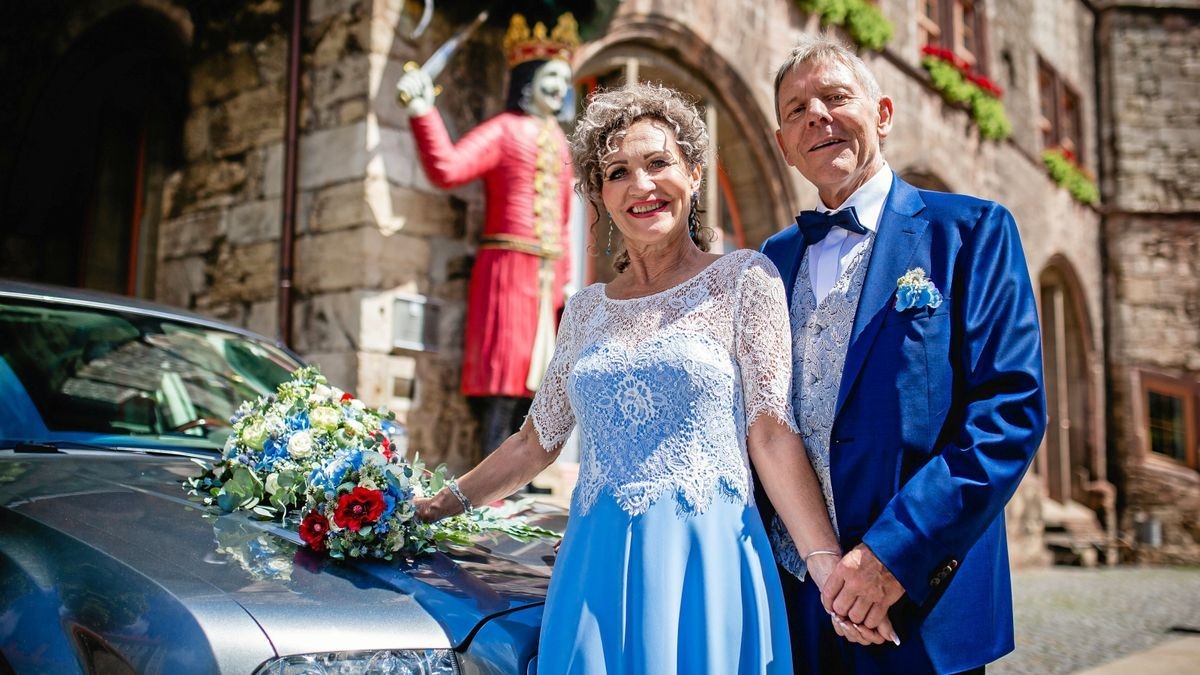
[775,62,892,208]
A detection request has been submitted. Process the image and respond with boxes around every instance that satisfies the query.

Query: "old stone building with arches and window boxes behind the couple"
[0,0,1200,563]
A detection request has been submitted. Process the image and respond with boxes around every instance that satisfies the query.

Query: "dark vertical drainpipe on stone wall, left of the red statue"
[276,0,304,346]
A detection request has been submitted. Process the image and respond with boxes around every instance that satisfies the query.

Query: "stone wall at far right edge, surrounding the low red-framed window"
[1100,2,1200,563]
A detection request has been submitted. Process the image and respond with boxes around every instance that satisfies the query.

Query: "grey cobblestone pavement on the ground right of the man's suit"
[988,567,1200,675]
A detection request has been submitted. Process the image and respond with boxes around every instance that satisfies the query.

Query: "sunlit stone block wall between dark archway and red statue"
[147,0,489,471]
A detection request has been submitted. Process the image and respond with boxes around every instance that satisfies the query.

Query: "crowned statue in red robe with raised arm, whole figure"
[396,14,578,454]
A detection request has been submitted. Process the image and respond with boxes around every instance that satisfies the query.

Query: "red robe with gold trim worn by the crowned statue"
[410,108,575,398]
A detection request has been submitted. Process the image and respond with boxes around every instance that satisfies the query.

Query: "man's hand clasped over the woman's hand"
[821,544,904,631]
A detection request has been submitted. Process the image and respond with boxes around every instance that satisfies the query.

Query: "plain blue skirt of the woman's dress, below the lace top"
[538,492,792,675]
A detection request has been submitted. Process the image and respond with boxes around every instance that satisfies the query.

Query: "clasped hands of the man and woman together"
[809,544,904,645]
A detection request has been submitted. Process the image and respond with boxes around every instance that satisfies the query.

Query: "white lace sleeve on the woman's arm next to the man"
[734,253,798,432]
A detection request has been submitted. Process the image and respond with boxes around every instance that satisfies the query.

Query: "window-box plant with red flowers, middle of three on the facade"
[920,44,1013,141]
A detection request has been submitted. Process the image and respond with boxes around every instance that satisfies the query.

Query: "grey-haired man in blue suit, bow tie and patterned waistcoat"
[763,36,1046,674]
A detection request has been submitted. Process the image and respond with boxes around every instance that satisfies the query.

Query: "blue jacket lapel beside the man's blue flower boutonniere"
[835,177,929,418]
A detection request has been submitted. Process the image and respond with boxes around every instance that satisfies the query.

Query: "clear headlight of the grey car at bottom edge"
[254,650,458,675]
